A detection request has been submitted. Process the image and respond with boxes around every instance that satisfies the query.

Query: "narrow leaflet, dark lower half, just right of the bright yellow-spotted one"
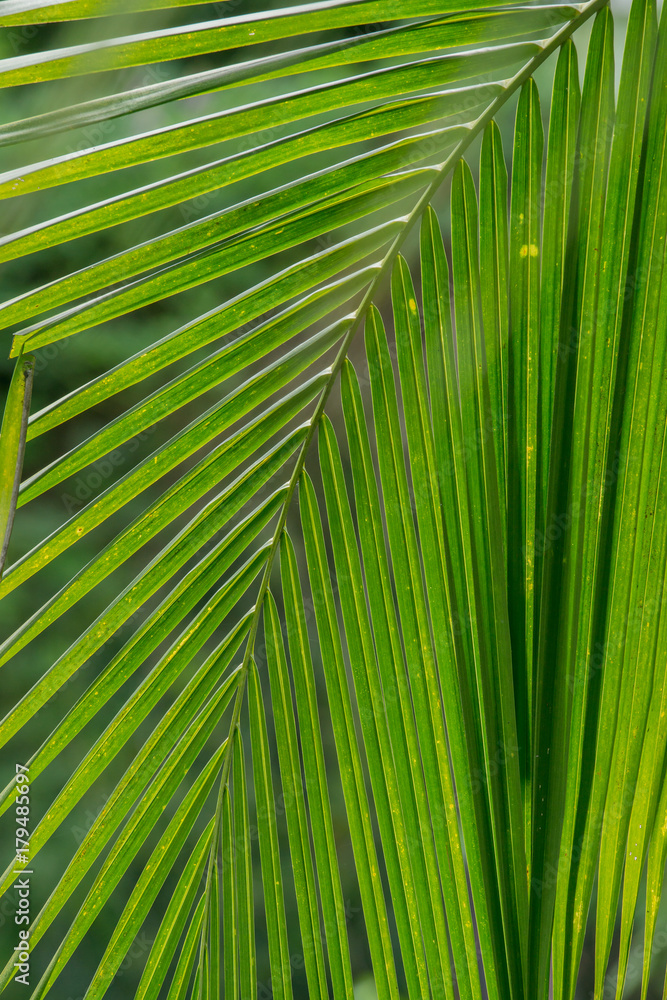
[528,41,581,1000]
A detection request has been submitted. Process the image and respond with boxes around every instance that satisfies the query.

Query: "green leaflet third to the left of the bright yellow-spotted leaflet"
[420,210,507,997]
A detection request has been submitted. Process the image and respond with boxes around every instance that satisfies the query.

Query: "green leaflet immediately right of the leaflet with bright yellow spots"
[514,43,580,996]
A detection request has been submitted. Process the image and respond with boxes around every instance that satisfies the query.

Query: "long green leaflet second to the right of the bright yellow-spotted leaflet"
[547,11,614,1000]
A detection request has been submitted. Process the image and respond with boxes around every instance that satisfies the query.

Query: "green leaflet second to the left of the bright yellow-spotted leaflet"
[452,156,528,996]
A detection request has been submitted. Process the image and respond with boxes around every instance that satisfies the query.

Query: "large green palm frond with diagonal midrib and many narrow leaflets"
[0,0,667,1000]
